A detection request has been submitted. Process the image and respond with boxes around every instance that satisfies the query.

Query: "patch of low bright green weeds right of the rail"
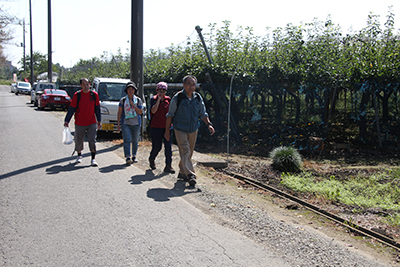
[281,169,400,225]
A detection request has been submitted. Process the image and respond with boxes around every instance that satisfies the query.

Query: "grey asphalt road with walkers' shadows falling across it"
[0,86,289,267]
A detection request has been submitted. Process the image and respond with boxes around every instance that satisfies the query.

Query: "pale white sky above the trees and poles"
[0,0,400,68]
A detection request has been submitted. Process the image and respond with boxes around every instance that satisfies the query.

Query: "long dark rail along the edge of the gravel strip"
[225,170,400,251]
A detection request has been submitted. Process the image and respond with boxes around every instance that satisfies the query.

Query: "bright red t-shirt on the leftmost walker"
[71,91,100,126]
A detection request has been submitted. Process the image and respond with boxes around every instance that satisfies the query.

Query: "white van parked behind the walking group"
[90,77,146,131]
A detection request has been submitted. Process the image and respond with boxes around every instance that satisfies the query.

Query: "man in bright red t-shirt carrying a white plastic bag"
[64,78,101,166]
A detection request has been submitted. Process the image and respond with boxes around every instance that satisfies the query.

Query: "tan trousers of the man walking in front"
[174,130,197,175]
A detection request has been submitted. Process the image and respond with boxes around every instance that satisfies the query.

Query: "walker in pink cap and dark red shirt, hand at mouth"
[149,82,175,173]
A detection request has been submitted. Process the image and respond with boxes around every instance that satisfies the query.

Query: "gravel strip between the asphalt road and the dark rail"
[99,136,400,267]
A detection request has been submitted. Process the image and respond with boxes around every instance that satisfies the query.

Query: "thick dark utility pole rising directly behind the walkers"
[130,0,146,136]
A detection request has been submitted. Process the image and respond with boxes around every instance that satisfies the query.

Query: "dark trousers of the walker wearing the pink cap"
[149,128,172,165]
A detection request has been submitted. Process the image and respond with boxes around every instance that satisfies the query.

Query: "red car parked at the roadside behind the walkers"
[38,89,71,109]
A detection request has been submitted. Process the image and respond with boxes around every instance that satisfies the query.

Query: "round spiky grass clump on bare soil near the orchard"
[270,146,303,172]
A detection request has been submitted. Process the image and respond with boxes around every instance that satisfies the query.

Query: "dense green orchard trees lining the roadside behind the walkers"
[6,7,400,151]
